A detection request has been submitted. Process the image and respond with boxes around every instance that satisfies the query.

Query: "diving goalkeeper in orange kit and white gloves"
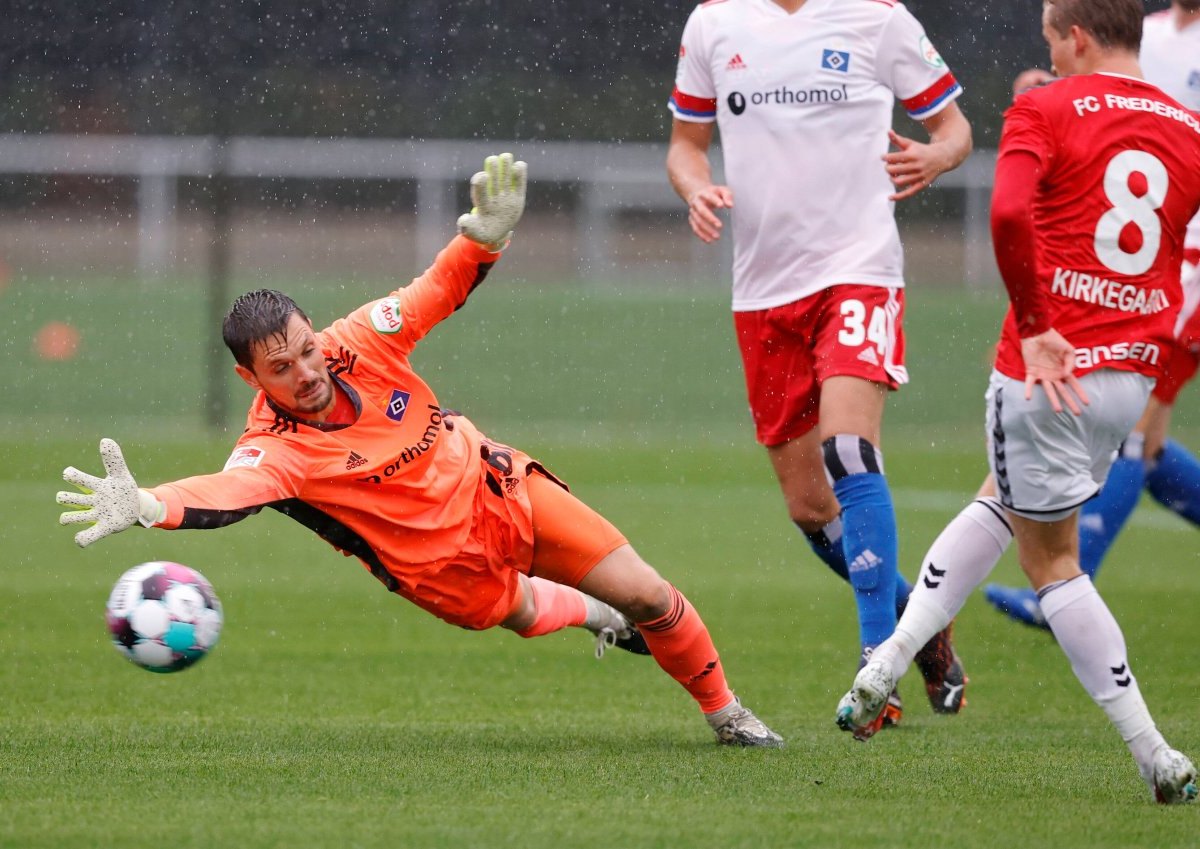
[58,153,782,746]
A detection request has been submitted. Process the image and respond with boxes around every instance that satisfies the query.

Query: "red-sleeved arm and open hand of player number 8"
[991,150,1088,416]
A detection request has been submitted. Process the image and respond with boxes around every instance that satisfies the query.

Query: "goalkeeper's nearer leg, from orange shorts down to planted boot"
[528,475,782,746]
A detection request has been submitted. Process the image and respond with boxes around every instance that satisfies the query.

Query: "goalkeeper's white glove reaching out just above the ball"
[55,439,167,548]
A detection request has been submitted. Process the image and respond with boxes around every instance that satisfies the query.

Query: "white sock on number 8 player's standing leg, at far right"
[1039,574,1166,781]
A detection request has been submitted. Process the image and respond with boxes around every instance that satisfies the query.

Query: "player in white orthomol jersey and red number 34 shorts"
[667,0,971,734]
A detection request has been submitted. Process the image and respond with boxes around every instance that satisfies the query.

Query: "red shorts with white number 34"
[733,284,908,445]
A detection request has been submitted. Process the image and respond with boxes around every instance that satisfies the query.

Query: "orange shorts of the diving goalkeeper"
[396,439,626,631]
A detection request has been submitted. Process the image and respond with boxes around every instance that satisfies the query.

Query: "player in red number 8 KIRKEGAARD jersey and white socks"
[836,0,1200,803]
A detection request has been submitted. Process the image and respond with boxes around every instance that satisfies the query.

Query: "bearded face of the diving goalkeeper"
[234,313,334,421]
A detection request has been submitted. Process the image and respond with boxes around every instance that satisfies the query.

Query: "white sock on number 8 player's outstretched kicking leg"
[872,496,1013,681]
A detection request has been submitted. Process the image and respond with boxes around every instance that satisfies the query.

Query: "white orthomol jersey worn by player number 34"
[670,0,962,311]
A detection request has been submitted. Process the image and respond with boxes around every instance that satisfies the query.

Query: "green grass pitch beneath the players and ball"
[0,270,1200,849]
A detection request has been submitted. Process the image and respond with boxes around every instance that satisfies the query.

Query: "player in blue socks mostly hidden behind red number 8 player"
[984,0,1200,628]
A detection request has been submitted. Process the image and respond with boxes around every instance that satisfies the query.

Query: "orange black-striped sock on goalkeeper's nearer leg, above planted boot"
[637,584,733,713]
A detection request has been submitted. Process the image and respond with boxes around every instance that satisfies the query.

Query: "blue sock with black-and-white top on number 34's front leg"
[822,434,899,648]
